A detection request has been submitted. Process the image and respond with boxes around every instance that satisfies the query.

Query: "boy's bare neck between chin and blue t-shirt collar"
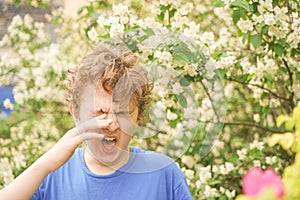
[83,147,130,175]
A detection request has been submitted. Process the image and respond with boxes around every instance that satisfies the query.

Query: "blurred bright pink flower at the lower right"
[243,168,284,197]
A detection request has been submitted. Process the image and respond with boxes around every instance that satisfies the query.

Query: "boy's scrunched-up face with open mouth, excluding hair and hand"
[77,84,138,166]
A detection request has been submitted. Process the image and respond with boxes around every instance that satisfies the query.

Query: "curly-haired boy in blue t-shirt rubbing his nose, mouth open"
[0,45,192,200]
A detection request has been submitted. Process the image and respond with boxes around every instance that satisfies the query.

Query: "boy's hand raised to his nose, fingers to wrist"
[37,114,112,173]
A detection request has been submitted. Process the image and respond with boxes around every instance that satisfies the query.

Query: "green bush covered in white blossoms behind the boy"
[0,0,300,199]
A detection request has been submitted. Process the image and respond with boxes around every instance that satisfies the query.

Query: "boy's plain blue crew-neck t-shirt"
[31,147,192,200]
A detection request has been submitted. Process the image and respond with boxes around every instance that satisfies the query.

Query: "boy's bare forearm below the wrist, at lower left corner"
[0,159,49,200]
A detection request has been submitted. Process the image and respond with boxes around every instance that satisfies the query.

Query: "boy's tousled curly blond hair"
[65,44,153,119]
